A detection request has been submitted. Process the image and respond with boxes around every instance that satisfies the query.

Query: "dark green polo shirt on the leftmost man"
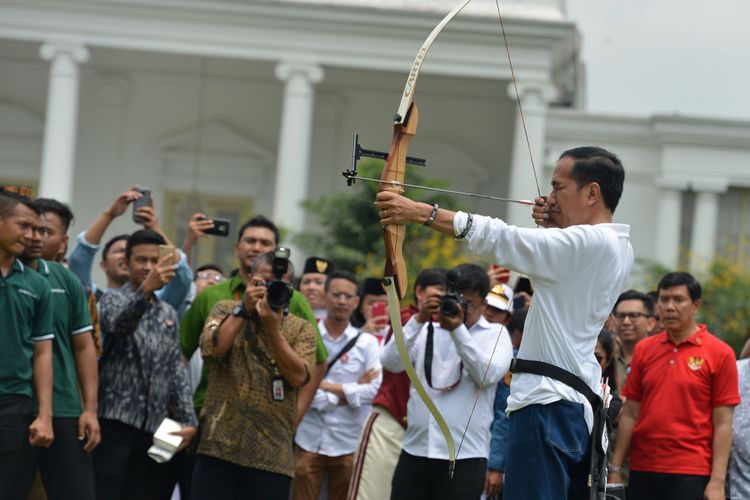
[0,259,55,400]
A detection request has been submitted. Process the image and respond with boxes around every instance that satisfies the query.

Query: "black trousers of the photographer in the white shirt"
[391,451,487,500]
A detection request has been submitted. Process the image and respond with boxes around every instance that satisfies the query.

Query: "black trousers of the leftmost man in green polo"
[0,396,36,500]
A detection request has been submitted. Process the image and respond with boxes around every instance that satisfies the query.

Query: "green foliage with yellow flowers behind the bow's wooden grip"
[295,160,465,286]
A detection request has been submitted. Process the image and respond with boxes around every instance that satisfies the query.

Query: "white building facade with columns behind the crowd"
[0,0,750,278]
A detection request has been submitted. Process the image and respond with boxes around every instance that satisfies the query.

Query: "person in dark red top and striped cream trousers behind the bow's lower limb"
[348,269,446,500]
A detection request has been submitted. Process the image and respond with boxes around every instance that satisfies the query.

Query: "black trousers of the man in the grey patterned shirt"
[93,418,163,500]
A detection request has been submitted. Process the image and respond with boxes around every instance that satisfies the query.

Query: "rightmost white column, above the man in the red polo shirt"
[690,182,727,269]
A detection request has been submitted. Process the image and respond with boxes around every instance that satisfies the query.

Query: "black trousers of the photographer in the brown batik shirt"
[190,455,292,500]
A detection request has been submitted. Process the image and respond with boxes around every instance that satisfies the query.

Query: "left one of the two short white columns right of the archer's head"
[655,179,687,269]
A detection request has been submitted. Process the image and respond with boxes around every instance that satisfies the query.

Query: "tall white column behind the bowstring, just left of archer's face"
[505,83,554,227]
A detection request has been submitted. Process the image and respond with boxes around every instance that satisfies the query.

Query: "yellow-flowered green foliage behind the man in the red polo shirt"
[638,257,750,353]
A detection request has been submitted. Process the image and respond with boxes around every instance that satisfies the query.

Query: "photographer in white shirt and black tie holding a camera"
[381,264,513,500]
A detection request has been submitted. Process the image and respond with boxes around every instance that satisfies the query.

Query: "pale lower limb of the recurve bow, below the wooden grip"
[383,278,456,477]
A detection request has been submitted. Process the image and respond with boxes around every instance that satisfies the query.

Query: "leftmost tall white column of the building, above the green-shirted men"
[39,43,89,203]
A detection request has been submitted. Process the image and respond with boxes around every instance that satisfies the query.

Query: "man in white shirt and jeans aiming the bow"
[375,147,633,500]
